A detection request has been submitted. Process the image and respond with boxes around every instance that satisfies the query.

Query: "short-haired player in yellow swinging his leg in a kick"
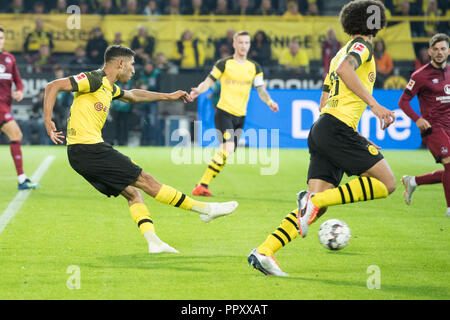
[44,45,238,253]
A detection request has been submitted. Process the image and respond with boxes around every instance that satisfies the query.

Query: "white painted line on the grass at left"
[0,156,55,233]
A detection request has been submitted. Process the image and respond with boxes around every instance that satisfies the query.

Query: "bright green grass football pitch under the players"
[0,146,450,300]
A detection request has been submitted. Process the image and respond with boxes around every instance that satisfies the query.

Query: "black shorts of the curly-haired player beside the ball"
[308,113,383,187]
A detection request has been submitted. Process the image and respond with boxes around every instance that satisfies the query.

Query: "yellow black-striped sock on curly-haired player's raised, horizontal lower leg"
[311,177,388,208]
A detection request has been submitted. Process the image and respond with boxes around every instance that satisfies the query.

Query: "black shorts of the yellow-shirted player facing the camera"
[214,108,245,149]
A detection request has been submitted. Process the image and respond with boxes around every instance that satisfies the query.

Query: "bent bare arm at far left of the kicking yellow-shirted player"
[44,78,72,144]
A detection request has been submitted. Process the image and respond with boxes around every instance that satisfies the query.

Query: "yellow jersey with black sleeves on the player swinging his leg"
[67,69,124,145]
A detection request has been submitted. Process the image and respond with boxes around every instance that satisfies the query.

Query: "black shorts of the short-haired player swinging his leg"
[67,142,142,197]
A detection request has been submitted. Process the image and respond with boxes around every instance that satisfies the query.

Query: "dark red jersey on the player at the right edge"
[399,63,450,130]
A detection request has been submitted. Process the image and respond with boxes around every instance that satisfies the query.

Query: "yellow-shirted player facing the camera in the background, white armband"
[190,31,279,197]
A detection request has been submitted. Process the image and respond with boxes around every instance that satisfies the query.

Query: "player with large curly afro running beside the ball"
[248,0,396,276]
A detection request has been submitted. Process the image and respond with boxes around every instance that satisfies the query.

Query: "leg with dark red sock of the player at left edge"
[1,120,39,190]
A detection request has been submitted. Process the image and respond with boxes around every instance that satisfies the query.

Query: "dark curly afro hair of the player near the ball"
[339,0,386,37]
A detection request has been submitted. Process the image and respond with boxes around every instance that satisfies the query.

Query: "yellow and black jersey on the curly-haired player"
[322,37,376,130]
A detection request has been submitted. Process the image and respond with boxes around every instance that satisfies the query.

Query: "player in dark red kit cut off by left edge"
[0,27,39,190]
